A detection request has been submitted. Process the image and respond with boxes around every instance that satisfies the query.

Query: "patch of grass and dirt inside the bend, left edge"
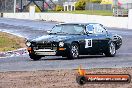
[0,32,26,51]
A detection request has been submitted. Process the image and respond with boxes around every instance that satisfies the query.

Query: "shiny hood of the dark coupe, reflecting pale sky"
[32,35,79,42]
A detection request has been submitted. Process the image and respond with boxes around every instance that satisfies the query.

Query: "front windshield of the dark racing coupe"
[50,25,83,34]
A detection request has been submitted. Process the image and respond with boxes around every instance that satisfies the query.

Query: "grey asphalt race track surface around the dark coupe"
[0,18,132,72]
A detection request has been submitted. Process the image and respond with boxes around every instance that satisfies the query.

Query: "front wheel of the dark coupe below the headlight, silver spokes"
[68,43,79,59]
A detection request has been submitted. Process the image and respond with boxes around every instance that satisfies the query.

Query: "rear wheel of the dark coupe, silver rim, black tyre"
[105,42,116,57]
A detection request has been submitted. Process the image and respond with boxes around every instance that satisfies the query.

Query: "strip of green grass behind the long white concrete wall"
[48,10,113,16]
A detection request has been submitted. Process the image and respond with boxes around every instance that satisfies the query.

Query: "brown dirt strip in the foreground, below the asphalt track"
[0,68,132,88]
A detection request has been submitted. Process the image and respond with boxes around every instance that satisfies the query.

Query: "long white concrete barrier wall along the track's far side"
[3,12,129,29]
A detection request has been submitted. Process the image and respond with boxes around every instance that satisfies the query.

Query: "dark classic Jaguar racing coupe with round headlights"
[26,23,122,60]
